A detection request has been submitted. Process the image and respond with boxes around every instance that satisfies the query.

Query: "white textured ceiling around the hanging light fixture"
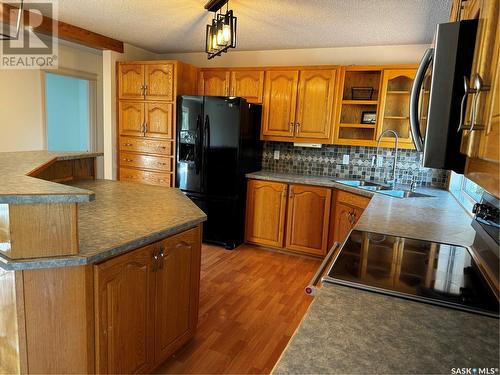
[58,0,451,53]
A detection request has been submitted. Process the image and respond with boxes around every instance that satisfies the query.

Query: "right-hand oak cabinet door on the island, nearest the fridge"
[154,227,201,364]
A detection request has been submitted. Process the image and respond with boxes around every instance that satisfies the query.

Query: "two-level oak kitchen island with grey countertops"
[0,152,206,373]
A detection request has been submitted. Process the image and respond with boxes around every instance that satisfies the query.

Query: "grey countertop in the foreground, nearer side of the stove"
[273,285,500,374]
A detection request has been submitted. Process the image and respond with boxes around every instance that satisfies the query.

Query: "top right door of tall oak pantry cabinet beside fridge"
[145,64,174,102]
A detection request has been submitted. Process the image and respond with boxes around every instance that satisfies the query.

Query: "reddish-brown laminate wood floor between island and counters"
[157,245,321,374]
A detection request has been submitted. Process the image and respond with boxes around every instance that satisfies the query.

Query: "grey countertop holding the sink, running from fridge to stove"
[247,171,475,246]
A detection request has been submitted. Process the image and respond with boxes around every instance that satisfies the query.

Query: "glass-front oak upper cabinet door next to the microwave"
[377,69,416,148]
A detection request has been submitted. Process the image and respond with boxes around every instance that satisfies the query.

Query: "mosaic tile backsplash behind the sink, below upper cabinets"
[262,142,449,188]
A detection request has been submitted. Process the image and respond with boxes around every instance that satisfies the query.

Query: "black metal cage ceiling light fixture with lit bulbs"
[205,0,237,60]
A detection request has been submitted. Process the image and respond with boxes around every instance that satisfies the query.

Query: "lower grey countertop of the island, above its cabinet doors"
[0,180,206,270]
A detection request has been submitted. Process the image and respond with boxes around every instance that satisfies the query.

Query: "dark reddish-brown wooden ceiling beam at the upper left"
[0,3,123,53]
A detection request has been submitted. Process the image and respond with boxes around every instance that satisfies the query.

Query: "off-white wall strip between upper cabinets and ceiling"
[160,44,428,68]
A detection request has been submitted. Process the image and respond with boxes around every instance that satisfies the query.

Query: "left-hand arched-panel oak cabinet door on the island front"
[95,245,157,374]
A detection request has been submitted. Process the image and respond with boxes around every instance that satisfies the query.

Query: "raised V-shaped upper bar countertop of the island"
[0,151,102,203]
